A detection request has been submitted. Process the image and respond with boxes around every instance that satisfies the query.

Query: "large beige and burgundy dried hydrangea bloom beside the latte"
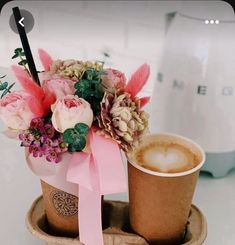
[97,91,149,152]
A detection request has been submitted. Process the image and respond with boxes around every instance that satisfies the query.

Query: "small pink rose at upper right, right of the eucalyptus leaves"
[102,68,126,92]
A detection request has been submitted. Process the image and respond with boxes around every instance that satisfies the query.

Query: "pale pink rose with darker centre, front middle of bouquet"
[51,95,93,132]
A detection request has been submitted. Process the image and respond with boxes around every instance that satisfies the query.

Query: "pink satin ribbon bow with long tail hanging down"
[67,129,127,245]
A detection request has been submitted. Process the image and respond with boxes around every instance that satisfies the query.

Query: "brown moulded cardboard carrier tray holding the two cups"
[26,197,207,245]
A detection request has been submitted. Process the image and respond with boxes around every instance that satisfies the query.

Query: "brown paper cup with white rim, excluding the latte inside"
[127,134,205,245]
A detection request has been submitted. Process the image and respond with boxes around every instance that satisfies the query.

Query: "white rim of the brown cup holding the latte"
[126,132,206,178]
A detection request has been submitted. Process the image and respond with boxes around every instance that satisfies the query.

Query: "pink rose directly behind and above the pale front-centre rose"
[42,75,76,99]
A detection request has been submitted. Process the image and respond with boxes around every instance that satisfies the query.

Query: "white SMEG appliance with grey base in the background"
[150,1,235,177]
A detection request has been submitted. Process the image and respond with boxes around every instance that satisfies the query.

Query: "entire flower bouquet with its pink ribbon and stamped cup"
[0,48,149,245]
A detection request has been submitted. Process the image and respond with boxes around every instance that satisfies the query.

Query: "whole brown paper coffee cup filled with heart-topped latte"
[127,133,205,245]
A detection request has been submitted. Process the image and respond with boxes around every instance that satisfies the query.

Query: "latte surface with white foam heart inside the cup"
[132,135,201,173]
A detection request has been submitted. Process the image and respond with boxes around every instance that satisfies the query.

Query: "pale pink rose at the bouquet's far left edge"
[0,91,35,130]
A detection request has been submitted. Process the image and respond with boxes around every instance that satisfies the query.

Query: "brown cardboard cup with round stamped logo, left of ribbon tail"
[41,180,78,237]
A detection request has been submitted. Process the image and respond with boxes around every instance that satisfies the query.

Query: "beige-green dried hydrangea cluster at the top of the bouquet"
[43,60,103,81]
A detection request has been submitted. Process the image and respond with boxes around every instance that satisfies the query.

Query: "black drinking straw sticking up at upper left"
[12,7,40,85]
